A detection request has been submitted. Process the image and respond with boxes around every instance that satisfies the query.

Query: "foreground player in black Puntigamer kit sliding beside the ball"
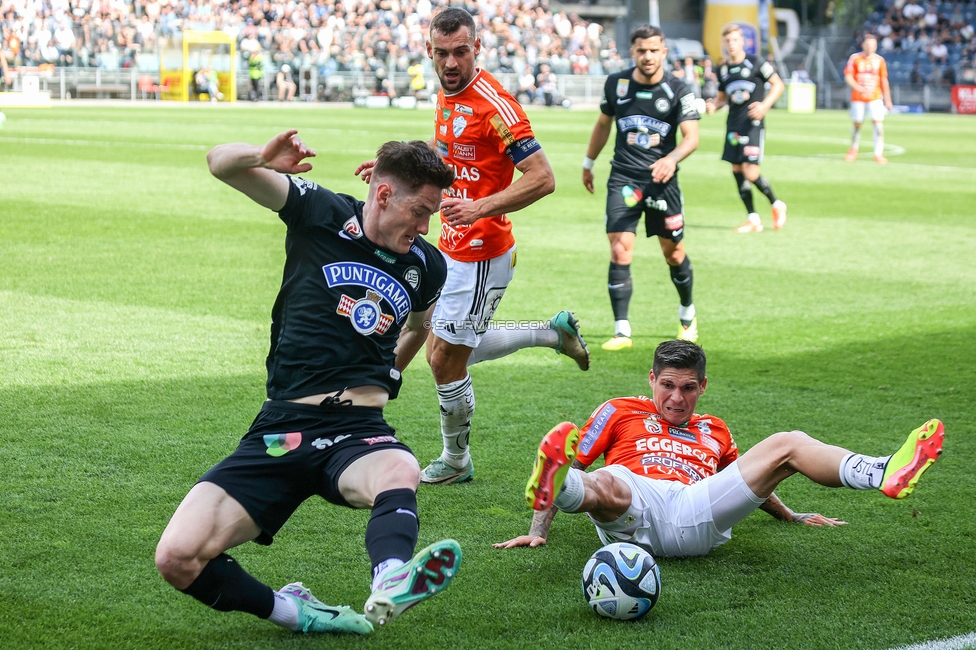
[156,131,461,634]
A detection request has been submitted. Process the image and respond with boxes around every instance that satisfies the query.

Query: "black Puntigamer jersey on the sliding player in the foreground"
[267,177,447,400]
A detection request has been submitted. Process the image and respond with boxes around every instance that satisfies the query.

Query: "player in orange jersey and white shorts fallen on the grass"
[495,340,945,557]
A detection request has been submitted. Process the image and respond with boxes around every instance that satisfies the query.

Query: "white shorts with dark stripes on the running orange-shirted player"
[430,246,515,348]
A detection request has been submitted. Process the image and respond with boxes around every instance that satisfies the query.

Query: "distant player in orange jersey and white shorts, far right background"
[844,33,891,165]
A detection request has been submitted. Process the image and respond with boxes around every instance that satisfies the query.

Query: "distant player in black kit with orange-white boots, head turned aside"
[705,24,786,232]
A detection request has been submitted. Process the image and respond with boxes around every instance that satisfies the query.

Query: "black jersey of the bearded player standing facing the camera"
[600,68,701,174]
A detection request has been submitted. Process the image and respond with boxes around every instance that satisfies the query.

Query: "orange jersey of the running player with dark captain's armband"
[434,69,541,262]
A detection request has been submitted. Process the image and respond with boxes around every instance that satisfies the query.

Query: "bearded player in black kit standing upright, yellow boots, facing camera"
[583,25,700,350]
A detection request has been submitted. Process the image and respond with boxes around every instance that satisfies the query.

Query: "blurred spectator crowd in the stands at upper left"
[0,0,624,80]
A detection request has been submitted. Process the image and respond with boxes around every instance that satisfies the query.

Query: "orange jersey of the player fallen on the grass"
[576,397,739,485]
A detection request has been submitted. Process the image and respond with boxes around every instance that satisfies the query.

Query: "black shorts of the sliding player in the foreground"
[200,400,412,545]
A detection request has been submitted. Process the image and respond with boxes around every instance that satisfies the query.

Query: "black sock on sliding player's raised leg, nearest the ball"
[366,488,420,577]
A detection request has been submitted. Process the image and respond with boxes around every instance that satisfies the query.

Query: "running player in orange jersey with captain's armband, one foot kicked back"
[356,7,590,485]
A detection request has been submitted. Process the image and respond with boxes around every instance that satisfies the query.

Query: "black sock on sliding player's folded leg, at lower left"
[180,553,274,618]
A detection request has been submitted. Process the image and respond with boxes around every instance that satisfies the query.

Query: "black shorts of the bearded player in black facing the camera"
[606,171,685,243]
